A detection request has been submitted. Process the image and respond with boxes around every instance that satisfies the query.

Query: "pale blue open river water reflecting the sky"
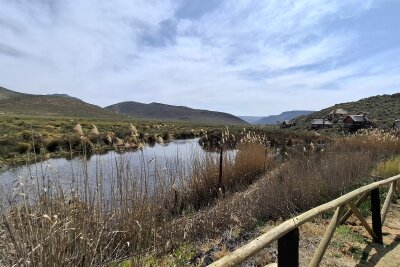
[0,139,235,198]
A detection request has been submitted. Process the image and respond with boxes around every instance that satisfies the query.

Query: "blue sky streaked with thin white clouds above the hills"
[0,0,400,115]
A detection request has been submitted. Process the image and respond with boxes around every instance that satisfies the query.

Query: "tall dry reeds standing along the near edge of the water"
[0,133,270,266]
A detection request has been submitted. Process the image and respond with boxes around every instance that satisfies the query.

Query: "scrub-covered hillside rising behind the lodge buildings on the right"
[296,93,400,128]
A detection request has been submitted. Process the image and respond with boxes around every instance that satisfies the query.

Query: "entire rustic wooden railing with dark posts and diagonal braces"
[209,175,400,267]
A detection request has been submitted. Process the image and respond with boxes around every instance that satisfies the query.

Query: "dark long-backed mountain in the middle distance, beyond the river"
[106,101,247,124]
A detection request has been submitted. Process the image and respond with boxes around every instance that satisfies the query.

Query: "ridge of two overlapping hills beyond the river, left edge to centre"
[0,87,247,125]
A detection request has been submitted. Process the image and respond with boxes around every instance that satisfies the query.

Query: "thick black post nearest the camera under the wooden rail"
[278,228,299,267]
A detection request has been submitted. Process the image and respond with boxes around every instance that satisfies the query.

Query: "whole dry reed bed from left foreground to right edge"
[0,129,400,266]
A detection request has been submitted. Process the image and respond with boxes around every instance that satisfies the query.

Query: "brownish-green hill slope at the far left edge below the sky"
[0,87,124,119]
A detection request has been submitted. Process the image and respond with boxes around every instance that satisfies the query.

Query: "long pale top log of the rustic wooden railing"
[209,175,400,267]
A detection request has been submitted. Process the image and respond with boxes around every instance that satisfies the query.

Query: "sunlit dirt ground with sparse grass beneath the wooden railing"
[199,200,400,267]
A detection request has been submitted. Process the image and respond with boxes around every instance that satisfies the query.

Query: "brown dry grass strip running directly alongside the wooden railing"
[154,131,400,255]
